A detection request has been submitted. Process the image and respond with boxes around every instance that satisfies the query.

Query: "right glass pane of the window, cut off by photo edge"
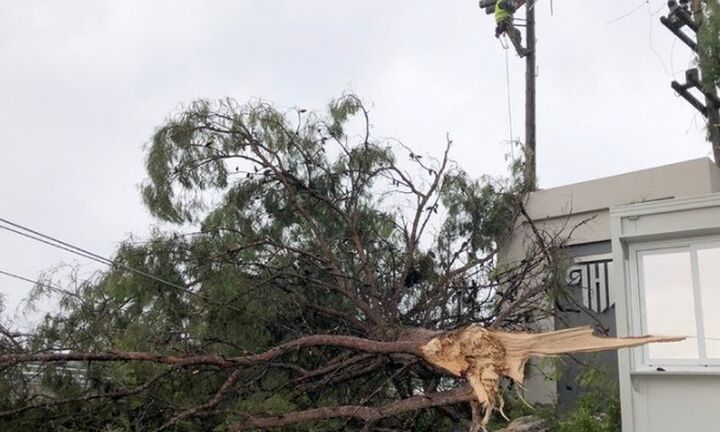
[697,247,720,359]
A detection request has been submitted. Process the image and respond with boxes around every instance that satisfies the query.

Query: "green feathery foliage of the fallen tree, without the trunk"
[0,95,523,432]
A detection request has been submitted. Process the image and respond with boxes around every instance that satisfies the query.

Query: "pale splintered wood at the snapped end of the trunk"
[421,325,685,428]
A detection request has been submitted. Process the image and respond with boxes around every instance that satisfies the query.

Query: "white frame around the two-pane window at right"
[628,236,720,373]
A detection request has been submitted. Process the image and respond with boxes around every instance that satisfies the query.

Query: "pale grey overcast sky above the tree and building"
[0,0,710,328]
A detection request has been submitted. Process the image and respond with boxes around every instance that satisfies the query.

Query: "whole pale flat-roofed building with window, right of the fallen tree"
[501,159,720,432]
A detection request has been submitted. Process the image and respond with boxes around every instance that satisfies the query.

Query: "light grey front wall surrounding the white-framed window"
[610,193,720,432]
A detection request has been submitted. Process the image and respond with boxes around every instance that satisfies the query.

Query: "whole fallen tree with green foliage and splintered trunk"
[0,96,684,431]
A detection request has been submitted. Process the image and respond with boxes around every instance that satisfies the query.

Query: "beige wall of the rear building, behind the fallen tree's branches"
[499,158,720,406]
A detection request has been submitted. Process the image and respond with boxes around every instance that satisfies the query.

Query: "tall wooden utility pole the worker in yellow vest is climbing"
[525,0,537,191]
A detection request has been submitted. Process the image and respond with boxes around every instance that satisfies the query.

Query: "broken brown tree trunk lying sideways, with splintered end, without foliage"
[0,325,684,432]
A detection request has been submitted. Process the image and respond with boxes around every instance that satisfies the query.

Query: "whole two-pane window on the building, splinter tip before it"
[632,240,720,367]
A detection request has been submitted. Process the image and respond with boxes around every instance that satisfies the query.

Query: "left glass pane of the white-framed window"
[642,251,699,359]
